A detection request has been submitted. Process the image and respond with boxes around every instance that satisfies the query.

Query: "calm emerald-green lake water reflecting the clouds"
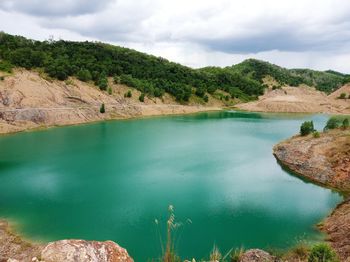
[0,112,341,261]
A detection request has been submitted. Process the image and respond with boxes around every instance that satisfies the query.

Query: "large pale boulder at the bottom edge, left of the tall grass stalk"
[41,240,134,262]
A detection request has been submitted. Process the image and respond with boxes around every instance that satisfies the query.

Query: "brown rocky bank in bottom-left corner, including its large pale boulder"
[0,220,133,262]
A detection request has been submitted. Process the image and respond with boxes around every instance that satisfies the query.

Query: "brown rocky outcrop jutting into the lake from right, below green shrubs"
[273,130,350,192]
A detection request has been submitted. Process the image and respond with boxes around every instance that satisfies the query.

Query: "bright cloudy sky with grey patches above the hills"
[0,0,350,73]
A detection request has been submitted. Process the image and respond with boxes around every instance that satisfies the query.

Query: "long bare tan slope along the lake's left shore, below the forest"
[0,69,223,134]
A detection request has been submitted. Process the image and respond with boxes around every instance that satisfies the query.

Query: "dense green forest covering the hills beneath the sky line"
[0,32,348,101]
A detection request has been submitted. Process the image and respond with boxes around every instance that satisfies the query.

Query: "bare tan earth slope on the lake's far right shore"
[237,85,350,114]
